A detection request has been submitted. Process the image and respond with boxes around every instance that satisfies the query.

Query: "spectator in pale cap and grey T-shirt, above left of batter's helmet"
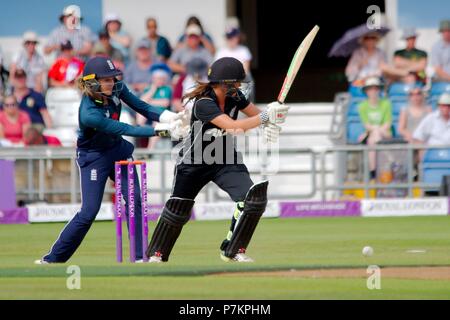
[168,25,213,73]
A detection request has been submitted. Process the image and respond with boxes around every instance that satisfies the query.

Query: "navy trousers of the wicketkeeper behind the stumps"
[43,140,142,262]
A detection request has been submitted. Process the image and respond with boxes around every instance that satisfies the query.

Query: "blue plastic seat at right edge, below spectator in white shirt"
[422,149,450,191]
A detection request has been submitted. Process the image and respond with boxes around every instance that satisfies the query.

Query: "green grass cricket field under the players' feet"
[0,217,450,299]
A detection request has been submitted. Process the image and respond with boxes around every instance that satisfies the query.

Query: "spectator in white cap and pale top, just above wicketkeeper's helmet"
[105,13,132,63]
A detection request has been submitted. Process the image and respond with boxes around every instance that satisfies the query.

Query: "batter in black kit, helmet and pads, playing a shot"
[146,57,289,262]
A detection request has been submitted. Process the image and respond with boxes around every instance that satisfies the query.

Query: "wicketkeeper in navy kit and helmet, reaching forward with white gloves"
[35,57,186,264]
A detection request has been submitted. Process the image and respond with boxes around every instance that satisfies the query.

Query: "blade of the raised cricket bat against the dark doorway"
[277,26,320,103]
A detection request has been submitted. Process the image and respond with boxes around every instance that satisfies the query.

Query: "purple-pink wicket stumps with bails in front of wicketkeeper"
[115,161,148,263]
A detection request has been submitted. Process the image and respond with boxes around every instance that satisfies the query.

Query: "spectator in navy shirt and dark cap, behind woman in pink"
[13,69,52,132]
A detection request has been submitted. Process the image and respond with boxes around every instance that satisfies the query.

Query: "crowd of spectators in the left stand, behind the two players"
[0,5,252,148]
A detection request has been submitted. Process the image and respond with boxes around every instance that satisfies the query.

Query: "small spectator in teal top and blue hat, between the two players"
[137,68,172,149]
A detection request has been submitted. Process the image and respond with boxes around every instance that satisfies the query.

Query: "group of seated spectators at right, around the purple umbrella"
[345,20,450,188]
